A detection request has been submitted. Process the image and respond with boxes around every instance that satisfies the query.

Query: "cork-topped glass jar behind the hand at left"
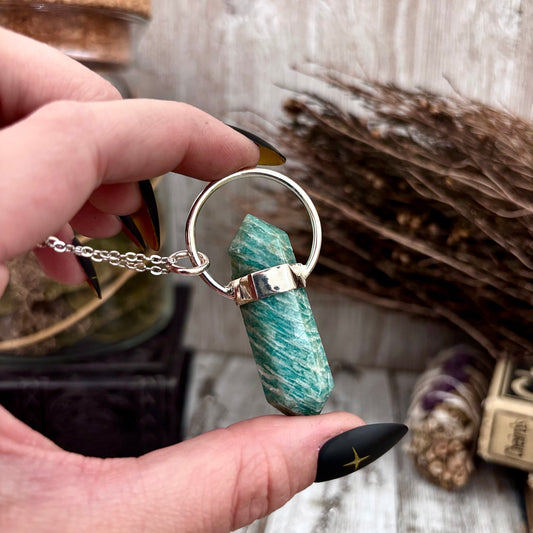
[0,0,174,359]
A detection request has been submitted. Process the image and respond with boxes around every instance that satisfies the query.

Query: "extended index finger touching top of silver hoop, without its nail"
[0,100,259,262]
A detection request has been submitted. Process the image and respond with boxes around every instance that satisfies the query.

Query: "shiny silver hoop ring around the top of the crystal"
[185,168,322,298]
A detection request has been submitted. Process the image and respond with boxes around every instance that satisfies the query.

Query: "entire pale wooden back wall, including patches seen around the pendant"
[135,0,533,370]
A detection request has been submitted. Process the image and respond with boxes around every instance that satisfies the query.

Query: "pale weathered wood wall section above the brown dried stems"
[141,0,533,120]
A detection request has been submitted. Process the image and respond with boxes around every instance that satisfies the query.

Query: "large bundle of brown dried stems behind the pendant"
[274,73,533,357]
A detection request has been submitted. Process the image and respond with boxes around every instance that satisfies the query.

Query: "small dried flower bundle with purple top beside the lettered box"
[406,346,493,490]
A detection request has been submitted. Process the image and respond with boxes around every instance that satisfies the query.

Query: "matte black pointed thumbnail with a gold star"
[315,423,407,482]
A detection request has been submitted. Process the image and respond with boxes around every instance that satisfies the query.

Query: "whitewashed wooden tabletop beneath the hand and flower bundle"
[187,352,525,533]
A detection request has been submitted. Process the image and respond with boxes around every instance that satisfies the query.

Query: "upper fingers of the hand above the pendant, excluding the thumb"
[0,30,259,294]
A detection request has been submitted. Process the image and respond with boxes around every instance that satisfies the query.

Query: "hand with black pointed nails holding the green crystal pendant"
[0,29,404,533]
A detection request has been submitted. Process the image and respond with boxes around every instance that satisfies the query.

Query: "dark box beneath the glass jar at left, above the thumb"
[0,286,191,457]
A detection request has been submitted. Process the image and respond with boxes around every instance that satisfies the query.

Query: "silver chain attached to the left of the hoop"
[40,237,209,276]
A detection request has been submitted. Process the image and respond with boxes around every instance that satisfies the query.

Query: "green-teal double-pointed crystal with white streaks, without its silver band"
[229,215,333,415]
